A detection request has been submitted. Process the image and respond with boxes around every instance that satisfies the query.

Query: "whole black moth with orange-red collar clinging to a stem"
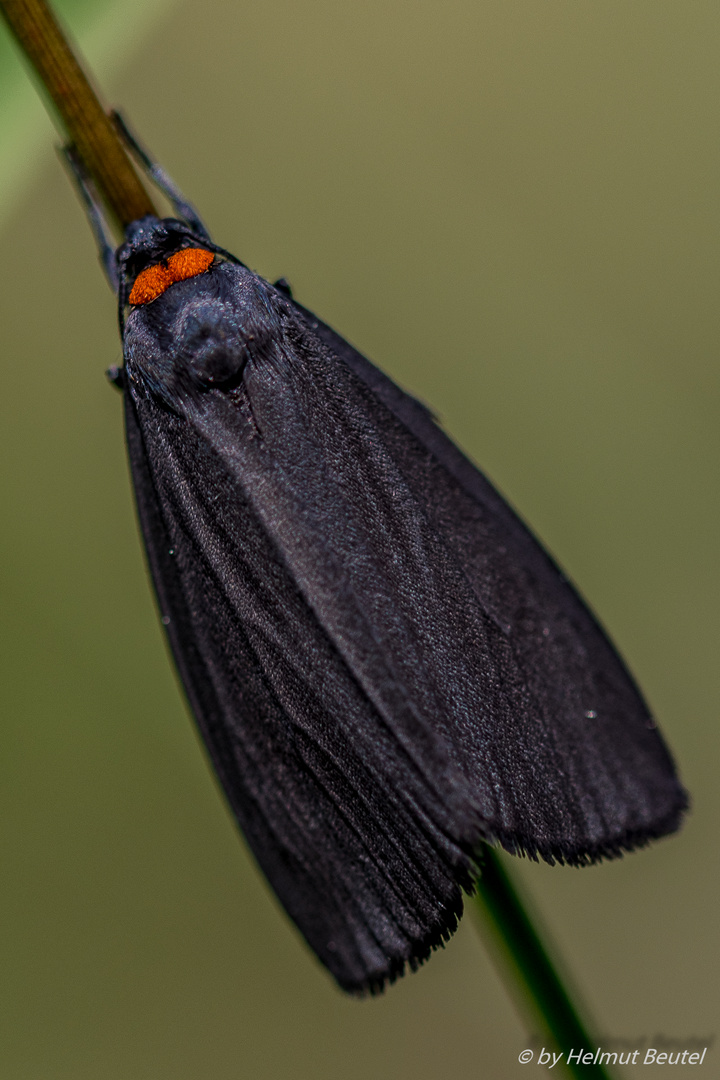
[69,122,687,993]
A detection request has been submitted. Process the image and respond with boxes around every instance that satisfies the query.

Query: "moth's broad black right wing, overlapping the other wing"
[183,298,685,863]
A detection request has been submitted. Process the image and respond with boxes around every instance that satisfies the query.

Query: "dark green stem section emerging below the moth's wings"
[475,847,610,1080]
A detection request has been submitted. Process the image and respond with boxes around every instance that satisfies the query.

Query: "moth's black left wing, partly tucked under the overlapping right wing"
[125,392,470,991]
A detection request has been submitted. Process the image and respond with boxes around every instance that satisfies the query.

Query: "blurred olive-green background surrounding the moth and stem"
[0,0,720,1080]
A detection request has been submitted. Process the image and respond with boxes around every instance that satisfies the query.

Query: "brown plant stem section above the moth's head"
[0,0,155,231]
